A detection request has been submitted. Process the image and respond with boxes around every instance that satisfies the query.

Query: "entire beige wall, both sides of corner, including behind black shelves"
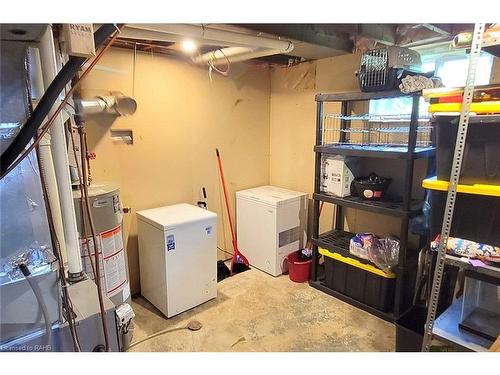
[83,49,500,293]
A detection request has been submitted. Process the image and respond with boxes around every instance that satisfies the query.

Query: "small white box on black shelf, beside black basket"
[320,156,354,197]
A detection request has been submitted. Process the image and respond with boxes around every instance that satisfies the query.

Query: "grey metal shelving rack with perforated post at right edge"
[422,24,500,351]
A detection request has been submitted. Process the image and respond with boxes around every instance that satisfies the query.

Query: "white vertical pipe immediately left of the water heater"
[40,26,83,280]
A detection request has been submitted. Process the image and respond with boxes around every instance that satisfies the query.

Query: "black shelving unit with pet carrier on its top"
[309,90,435,321]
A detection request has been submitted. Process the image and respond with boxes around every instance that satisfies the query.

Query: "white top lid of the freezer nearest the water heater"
[136,203,217,230]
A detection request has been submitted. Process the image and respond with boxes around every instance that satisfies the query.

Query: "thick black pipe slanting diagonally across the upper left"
[0,24,116,176]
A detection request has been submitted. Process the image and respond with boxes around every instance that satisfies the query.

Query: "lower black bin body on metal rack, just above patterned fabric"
[429,190,500,246]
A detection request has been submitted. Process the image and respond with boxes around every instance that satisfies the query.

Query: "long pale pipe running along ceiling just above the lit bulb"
[126,24,294,53]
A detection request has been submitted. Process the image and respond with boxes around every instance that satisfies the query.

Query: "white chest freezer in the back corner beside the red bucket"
[236,186,308,276]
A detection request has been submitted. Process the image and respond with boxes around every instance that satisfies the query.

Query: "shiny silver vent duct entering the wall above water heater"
[77,95,137,116]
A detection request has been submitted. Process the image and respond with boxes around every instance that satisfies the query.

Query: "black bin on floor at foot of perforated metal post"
[396,305,427,352]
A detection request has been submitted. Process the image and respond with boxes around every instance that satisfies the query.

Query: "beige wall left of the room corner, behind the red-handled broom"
[82,48,270,293]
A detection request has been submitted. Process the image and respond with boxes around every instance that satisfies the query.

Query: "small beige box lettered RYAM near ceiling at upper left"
[63,23,95,57]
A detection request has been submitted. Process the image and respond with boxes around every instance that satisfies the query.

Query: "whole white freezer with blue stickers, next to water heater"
[137,204,217,318]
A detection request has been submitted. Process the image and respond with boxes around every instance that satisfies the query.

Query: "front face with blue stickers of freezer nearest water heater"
[165,219,217,318]
